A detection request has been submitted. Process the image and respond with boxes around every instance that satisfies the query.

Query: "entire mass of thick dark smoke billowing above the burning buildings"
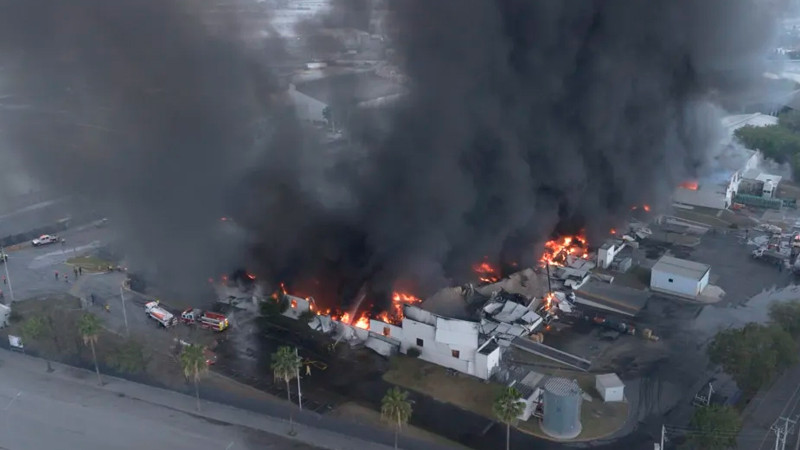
[0,0,788,306]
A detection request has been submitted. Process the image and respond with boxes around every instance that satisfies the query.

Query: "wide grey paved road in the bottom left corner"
[0,351,328,450]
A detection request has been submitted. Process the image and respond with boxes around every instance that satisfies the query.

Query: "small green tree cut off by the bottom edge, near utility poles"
[688,405,742,450]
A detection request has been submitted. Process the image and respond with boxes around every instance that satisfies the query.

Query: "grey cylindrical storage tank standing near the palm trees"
[542,378,583,439]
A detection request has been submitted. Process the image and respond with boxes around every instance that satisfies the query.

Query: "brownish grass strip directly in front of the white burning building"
[383,355,502,419]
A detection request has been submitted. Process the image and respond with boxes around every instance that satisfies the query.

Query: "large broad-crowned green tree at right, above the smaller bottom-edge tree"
[708,323,797,393]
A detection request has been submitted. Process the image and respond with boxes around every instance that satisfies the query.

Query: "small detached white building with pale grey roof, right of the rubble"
[650,255,711,300]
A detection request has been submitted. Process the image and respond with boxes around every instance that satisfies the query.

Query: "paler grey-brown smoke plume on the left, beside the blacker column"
[0,0,303,294]
